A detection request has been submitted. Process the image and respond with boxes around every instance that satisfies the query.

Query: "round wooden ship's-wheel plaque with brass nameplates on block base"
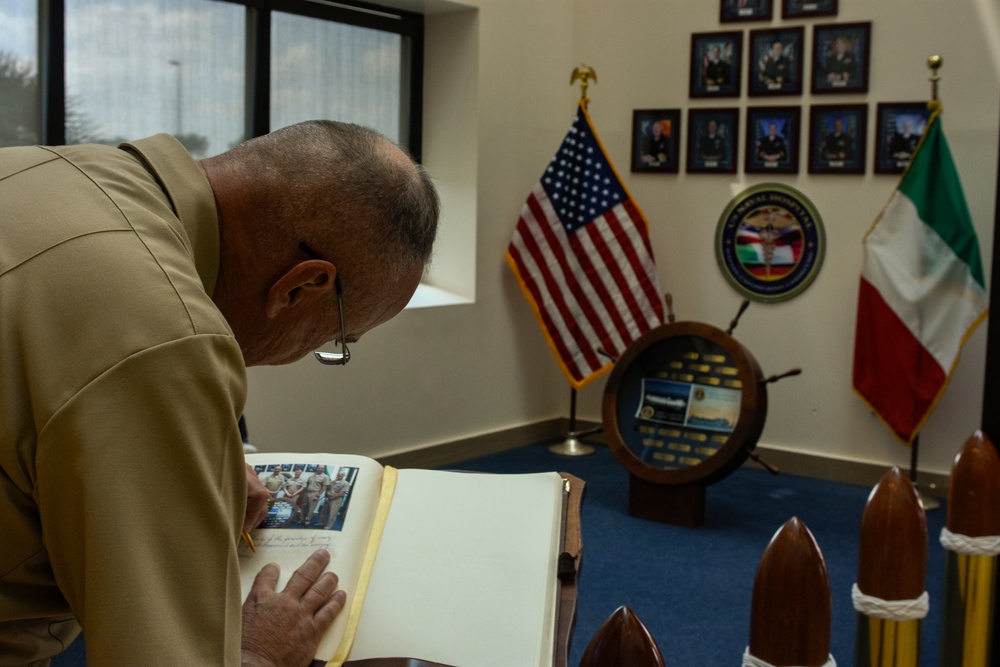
[602,322,767,528]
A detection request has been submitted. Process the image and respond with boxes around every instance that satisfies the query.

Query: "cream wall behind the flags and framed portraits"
[247,0,1000,480]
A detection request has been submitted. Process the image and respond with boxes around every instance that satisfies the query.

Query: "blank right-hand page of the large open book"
[350,470,564,667]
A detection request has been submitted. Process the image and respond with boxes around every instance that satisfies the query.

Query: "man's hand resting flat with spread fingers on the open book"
[243,549,347,667]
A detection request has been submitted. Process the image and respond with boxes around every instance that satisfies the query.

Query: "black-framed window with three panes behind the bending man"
[0,0,423,157]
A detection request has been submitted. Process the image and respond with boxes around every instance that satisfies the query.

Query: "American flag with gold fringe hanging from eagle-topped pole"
[507,100,663,389]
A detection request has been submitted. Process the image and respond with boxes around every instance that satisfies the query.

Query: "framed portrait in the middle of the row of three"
[747,26,805,97]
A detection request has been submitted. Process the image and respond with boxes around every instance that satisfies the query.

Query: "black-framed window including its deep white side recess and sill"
[0,0,478,307]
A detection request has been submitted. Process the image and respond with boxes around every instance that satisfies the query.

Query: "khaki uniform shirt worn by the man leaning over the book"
[0,135,246,666]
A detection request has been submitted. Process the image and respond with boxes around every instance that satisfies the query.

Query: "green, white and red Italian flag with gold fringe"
[854,103,988,444]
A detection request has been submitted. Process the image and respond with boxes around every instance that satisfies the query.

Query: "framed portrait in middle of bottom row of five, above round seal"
[743,106,802,174]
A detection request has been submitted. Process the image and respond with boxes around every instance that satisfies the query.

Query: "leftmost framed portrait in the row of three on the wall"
[688,30,743,98]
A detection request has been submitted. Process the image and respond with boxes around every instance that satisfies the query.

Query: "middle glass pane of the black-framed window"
[65,0,247,157]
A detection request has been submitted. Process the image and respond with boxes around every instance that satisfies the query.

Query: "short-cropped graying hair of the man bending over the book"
[226,120,441,288]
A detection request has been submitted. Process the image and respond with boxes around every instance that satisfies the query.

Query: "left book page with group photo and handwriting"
[239,453,382,660]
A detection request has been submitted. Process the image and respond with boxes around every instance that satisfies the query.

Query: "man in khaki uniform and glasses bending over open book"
[0,121,438,667]
